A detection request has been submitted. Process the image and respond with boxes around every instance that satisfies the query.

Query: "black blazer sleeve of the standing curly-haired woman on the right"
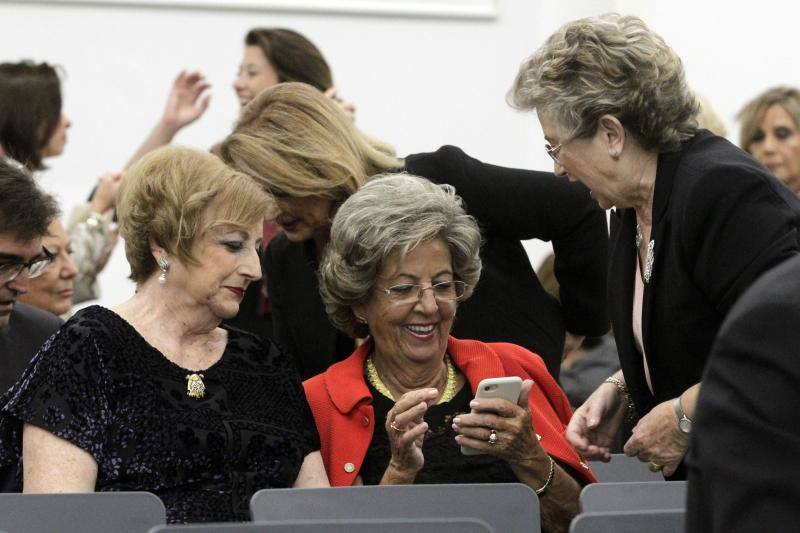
[680,165,800,315]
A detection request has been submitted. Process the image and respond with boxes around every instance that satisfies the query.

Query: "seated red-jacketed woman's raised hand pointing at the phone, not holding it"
[384,389,439,483]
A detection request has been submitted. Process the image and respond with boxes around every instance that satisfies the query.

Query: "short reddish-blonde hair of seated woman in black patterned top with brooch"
[117,146,270,283]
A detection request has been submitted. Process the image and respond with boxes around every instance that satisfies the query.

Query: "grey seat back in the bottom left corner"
[0,492,166,533]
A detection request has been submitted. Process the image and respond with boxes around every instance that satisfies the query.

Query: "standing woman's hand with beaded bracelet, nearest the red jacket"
[566,383,628,462]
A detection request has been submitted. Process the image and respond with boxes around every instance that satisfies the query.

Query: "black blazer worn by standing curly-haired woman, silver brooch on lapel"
[608,130,800,416]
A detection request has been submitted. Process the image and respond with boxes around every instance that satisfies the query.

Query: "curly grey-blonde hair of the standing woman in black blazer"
[507,13,699,152]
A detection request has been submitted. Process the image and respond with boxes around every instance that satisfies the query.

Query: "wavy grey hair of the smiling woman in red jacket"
[318,173,481,337]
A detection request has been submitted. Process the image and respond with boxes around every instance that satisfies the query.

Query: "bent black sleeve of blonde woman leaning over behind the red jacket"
[405,146,609,335]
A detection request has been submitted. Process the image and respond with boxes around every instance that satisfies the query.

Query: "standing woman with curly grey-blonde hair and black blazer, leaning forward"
[510,14,800,477]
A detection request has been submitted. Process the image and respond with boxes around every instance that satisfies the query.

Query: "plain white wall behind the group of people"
[0,0,800,304]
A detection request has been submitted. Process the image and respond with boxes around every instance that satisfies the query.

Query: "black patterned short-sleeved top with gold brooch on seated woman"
[0,306,319,522]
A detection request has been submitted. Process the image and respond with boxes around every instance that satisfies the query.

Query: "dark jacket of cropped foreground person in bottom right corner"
[687,252,800,533]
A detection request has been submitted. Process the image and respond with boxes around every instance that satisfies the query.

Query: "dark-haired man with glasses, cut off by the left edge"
[0,159,61,394]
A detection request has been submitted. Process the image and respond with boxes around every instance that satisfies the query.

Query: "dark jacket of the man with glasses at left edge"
[0,302,62,395]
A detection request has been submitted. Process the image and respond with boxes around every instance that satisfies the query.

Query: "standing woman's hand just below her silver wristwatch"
[624,400,689,476]
